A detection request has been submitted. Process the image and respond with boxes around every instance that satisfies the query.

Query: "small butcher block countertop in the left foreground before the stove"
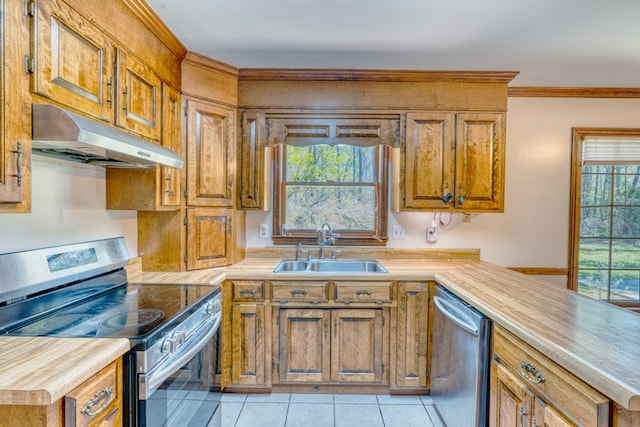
[0,336,130,405]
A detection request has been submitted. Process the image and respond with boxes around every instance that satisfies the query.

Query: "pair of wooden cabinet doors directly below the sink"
[274,308,389,384]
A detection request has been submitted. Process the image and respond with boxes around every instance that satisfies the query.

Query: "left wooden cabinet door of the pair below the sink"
[278,308,331,383]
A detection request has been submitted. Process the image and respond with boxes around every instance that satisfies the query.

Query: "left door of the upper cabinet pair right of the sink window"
[400,113,455,210]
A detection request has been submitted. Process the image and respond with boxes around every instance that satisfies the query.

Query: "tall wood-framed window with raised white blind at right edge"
[570,129,640,307]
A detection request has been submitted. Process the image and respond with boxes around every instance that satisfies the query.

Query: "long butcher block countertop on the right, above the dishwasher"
[436,263,640,411]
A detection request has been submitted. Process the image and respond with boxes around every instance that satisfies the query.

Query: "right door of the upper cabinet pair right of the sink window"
[454,113,505,212]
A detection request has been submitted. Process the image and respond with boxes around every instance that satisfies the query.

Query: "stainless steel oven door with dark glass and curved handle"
[131,313,221,427]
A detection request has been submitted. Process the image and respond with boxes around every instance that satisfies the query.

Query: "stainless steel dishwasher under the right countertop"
[431,286,490,427]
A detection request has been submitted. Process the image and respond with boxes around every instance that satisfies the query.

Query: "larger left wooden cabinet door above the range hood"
[30,0,115,122]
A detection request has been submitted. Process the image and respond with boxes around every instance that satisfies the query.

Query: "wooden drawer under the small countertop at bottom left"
[64,361,122,426]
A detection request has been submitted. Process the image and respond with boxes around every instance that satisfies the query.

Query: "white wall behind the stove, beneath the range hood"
[0,156,138,256]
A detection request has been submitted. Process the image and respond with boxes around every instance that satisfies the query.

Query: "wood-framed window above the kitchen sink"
[273,144,389,245]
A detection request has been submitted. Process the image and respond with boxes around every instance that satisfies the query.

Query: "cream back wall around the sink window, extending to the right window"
[247,98,640,268]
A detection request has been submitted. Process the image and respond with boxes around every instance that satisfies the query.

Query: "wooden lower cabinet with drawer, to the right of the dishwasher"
[489,326,612,427]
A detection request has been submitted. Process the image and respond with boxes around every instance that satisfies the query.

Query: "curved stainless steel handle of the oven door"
[139,313,222,400]
